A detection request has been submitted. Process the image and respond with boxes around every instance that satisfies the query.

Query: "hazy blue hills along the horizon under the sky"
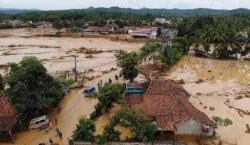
[0,7,250,17]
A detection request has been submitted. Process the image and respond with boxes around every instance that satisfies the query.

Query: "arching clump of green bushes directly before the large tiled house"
[99,108,157,142]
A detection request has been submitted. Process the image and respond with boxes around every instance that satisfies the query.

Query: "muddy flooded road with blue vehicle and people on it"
[0,70,122,145]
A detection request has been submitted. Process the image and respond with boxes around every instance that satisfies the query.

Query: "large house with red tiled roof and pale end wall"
[125,80,214,136]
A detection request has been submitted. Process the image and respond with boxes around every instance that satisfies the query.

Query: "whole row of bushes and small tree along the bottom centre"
[72,108,157,145]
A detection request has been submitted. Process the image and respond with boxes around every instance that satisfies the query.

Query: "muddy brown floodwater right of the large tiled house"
[165,56,250,145]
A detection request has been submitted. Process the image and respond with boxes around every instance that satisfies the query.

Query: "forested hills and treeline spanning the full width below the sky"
[0,7,250,28]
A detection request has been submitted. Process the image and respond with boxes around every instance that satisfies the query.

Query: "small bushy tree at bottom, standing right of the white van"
[72,118,95,142]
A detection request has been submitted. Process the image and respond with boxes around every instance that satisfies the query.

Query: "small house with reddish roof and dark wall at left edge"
[0,97,17,139]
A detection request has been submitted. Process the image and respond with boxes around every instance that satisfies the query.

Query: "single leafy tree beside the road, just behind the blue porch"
[116,51,139,81]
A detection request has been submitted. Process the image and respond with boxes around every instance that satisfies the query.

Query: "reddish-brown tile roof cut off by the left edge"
[0,97,17,131]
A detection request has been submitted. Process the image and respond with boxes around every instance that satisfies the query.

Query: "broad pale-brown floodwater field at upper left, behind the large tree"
[0,36,143,73]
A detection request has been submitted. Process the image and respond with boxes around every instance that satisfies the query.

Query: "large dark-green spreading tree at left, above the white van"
[5,57,64,121]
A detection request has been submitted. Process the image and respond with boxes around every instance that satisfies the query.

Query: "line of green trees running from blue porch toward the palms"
[115,40,188,82]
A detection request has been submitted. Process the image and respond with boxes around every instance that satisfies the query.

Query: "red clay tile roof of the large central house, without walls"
[132,80,213,131]
